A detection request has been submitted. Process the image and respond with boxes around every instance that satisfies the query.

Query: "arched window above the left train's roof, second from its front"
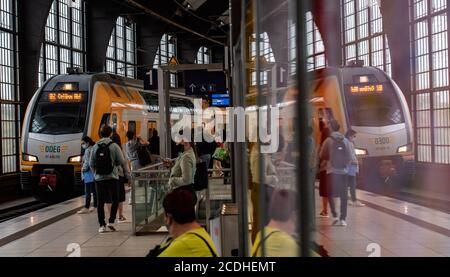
[105,16,136,78]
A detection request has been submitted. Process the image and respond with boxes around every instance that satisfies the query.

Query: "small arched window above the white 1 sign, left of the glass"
[153,34,178,88]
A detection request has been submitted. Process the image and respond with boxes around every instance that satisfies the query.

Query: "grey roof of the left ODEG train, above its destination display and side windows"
[42,72,144,91]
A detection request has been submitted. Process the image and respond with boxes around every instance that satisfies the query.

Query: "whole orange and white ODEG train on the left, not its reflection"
[21,73,193,200]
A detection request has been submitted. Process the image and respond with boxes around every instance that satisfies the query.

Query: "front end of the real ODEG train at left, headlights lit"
[21,74,89,201]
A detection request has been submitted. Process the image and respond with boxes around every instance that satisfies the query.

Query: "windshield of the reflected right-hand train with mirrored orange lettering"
[345,83,405,127]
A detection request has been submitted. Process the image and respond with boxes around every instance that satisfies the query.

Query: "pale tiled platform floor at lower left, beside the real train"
[0,195,166,257]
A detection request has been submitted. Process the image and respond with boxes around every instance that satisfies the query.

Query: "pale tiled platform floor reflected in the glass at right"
[315,188,450,257]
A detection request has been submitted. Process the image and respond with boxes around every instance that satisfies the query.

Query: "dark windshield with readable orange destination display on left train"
[29,92,87,135]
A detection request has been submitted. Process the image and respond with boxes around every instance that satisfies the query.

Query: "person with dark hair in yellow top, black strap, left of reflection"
[158,190,217,257]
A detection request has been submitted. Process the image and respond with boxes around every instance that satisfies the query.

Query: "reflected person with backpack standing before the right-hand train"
[319,119,352,226]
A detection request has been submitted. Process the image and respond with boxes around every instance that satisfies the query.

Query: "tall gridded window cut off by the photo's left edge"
[0,0,21,172]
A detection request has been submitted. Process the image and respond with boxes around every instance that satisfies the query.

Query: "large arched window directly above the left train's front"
[39,0,86,86]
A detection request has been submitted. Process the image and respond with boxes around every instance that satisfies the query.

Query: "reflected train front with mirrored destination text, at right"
[342,67,415,189]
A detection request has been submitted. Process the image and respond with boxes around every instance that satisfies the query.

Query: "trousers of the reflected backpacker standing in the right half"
[327,173,348,220]
